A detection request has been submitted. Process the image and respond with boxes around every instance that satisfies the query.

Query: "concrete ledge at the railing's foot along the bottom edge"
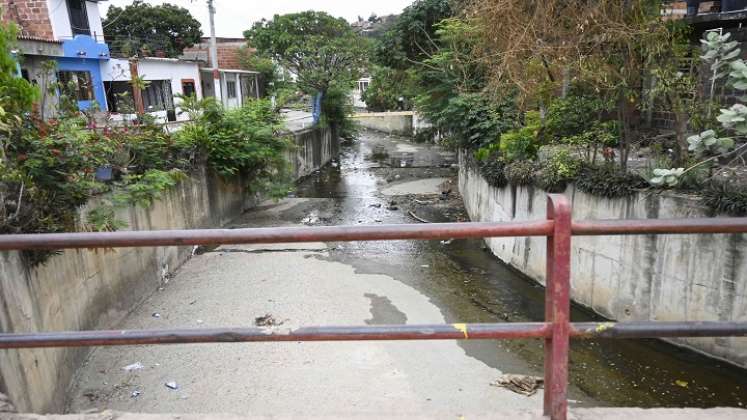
[0,407,747,420]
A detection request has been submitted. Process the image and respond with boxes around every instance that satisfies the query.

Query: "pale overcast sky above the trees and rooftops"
[99,0,413,37]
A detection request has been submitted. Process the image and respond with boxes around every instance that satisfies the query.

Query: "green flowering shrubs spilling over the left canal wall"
[0,18,289,262]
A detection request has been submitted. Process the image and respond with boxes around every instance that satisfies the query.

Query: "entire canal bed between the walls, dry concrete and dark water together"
[68,132,747,418]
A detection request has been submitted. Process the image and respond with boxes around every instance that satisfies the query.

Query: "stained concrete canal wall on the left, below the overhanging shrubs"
[0,125,338,413]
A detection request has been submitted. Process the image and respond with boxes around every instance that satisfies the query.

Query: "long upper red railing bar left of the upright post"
[0,220,553,251]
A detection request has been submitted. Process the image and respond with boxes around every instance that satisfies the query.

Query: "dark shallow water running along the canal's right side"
[290,132,747,407]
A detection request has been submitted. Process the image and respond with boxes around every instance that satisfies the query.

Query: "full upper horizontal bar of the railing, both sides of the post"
[0,217,747,251]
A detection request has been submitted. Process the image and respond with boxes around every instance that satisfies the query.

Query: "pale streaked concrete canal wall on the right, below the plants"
[459,155,747,367]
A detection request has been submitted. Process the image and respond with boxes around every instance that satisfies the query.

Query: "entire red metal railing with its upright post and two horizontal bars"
[0,195,747,420]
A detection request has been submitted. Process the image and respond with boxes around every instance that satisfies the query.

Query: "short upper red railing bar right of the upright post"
[571,217,747,235]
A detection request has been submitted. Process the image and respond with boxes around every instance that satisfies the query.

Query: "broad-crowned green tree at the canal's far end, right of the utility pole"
[244,11,367,95]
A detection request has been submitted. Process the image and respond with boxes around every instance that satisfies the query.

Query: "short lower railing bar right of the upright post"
[571,321,747,338]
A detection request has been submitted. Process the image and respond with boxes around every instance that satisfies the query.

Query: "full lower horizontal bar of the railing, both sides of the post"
[0,321,747,349]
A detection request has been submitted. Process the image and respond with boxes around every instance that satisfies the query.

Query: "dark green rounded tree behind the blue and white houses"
[103,1,202,57]
